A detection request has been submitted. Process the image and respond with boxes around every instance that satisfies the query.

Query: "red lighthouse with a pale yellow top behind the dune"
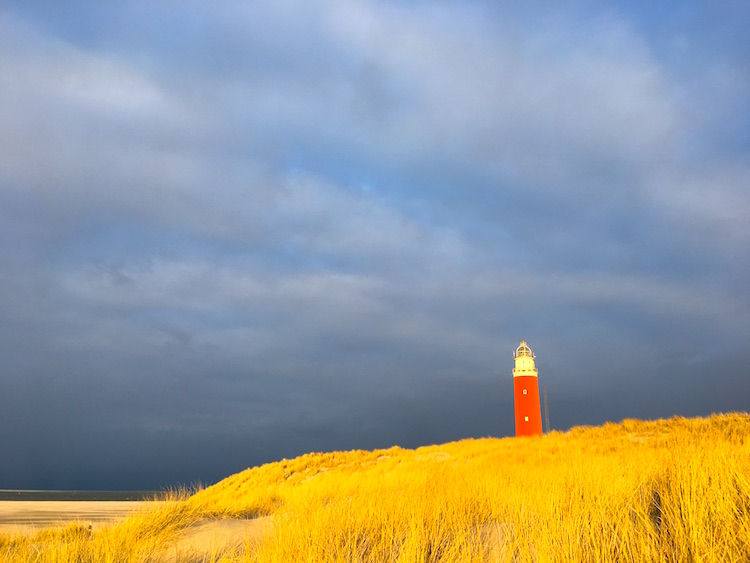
[513,340,542,436]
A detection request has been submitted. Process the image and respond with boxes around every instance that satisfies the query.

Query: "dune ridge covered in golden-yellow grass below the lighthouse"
[0,413,750,563]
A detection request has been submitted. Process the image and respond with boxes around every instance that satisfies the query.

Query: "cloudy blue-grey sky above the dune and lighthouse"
[0,0,750,489]
